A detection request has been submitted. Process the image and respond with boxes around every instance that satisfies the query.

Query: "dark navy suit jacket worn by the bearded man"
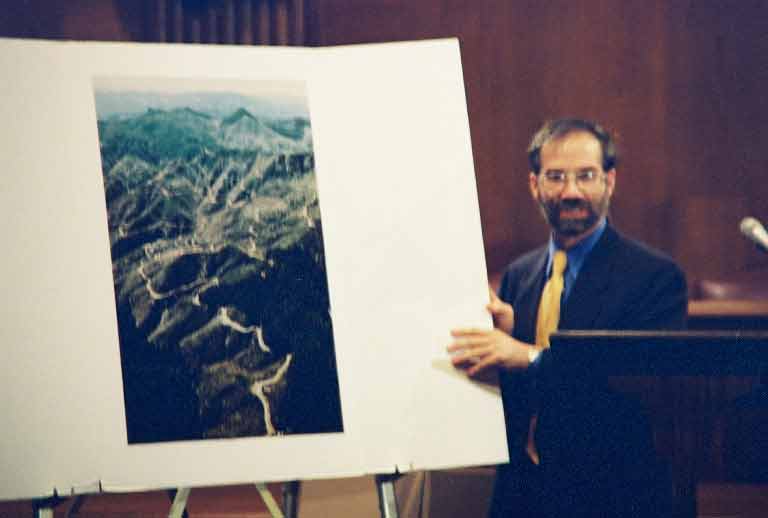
[492,225,687,516]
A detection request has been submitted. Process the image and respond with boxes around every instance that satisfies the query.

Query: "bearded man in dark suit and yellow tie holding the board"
[448,119,687,518]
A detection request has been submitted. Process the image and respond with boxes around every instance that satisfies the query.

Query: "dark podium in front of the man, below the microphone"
[551,331,768,518]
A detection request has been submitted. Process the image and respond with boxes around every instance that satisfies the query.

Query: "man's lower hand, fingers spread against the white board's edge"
[447,329,532,377]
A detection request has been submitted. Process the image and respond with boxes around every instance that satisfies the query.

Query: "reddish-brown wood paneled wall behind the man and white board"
[0,0,768,285]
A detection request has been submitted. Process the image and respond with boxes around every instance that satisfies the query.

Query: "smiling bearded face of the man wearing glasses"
[529,131,616,243]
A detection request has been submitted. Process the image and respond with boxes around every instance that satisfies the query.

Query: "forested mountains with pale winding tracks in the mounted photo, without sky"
[97,94,342,443]
